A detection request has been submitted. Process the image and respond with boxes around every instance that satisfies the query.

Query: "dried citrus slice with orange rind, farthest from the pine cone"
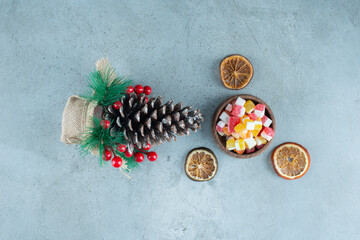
[271,142,311,180]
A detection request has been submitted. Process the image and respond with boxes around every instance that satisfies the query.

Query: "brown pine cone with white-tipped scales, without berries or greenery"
[103,93,204,152]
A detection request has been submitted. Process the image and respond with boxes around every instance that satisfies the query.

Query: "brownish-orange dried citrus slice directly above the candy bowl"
[220,55,254,89]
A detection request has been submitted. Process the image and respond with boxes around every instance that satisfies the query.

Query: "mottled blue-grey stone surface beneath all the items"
[0,0,360,240]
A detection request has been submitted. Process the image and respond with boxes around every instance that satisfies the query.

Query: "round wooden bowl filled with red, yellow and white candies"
[211,94,275,158]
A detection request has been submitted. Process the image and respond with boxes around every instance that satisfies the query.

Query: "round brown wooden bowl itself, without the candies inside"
[211,94,276,158]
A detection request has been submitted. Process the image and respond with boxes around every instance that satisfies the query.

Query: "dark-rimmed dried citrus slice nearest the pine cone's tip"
[185,148,218,181]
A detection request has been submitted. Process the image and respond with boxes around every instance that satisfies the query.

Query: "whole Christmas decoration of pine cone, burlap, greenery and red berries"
[61,59,203,174]
